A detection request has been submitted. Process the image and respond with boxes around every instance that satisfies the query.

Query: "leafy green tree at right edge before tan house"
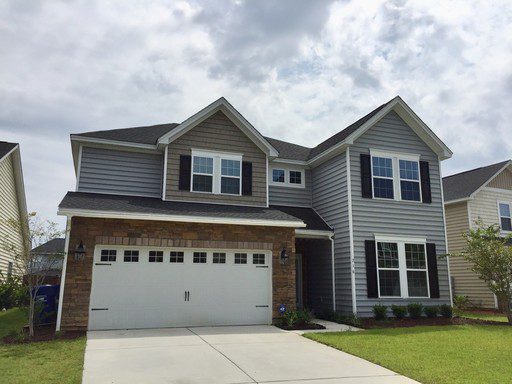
[451,220,512,324]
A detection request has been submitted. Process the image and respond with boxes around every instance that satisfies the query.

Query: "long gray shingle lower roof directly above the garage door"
[59,192,302,224]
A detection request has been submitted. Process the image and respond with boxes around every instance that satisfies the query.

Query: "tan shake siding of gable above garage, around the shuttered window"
[165,111,267,206]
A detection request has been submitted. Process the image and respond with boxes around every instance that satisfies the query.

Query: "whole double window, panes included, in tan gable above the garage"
[191,150,242,195]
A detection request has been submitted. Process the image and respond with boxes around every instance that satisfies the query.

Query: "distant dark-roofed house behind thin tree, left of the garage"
[28,238,66,284]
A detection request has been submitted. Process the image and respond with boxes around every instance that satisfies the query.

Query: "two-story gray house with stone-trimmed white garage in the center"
[57,97,452,329]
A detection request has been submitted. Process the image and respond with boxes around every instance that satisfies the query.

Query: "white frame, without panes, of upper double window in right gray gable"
[370,149,423,203]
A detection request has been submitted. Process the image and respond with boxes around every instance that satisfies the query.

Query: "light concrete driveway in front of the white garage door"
[83,326,416,384]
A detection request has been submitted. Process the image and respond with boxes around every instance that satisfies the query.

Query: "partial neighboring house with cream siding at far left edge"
[0,141,27,279]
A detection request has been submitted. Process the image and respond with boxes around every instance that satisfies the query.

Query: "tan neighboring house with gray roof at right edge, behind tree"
[443,160,512,308]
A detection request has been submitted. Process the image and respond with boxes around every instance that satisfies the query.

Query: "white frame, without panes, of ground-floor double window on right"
[375,235,431,300]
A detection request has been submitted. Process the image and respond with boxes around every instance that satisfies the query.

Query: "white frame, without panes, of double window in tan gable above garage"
[190,149,243,196]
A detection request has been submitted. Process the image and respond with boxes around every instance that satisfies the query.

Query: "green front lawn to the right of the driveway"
[305,325,512,384]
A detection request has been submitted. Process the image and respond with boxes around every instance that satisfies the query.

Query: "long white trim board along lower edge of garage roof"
[57,208,306,228]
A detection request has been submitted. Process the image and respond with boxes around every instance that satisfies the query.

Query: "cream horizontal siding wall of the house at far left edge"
[0,155,23,274]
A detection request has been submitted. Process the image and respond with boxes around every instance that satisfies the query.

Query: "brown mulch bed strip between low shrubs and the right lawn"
[360,317,508,329]
